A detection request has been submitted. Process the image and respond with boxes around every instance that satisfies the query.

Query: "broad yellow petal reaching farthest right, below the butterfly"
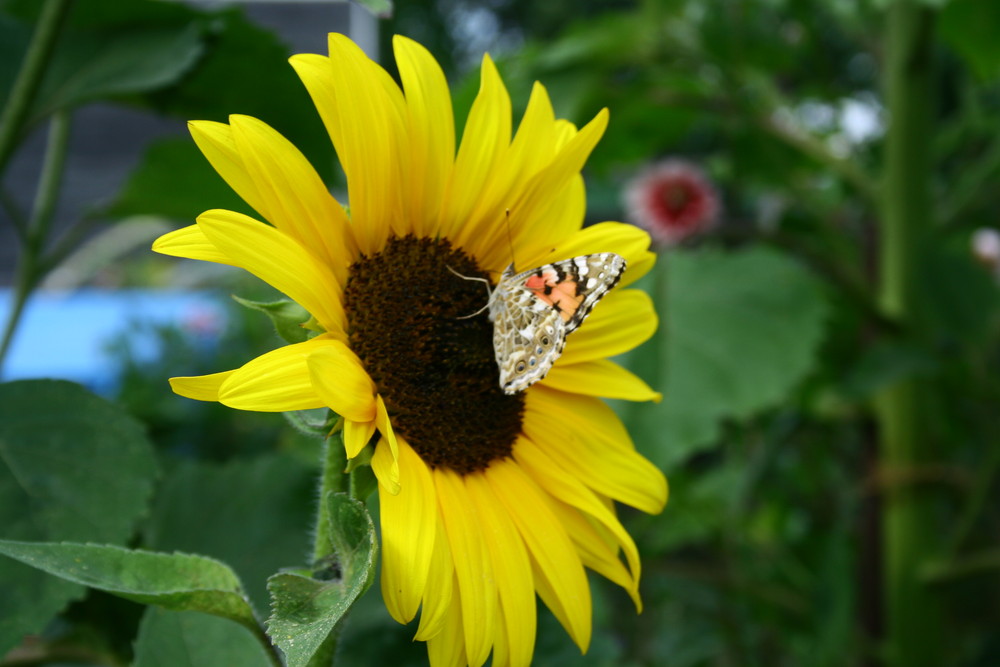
[523,385,667,514]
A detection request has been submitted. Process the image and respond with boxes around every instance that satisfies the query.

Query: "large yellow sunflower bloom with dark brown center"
[153,34,667,665]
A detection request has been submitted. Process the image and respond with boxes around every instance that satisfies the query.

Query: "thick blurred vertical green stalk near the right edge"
[875,0,944,667]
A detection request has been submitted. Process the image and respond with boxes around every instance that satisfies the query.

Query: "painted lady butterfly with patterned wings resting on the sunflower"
[487,252,625,394]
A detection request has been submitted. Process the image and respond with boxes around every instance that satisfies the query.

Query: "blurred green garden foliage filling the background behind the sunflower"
[0,0,1000,666]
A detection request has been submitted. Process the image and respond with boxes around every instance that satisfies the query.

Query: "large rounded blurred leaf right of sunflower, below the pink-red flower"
[622,247,827,468]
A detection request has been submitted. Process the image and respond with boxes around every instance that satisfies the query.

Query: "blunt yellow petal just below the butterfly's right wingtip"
[557,289,657,366]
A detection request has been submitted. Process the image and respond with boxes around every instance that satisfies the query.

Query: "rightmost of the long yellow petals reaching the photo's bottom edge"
[434,468,497,667]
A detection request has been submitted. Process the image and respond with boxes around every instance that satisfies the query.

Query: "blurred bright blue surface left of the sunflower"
[0,288,225,393]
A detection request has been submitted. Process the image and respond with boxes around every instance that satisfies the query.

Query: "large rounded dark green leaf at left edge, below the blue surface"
[0,380,157,654]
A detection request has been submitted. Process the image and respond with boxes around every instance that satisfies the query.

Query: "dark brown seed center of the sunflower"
[344,236,524,475]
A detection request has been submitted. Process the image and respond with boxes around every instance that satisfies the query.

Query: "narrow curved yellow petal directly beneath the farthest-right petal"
[514,438,641,605]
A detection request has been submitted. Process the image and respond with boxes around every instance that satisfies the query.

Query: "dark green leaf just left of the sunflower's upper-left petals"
[107,139,254,221]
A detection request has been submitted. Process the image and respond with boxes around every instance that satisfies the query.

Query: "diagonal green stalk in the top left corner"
[0,0,73,175]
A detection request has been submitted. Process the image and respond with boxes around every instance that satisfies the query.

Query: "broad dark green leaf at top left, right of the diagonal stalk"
[32,22,204,121]
